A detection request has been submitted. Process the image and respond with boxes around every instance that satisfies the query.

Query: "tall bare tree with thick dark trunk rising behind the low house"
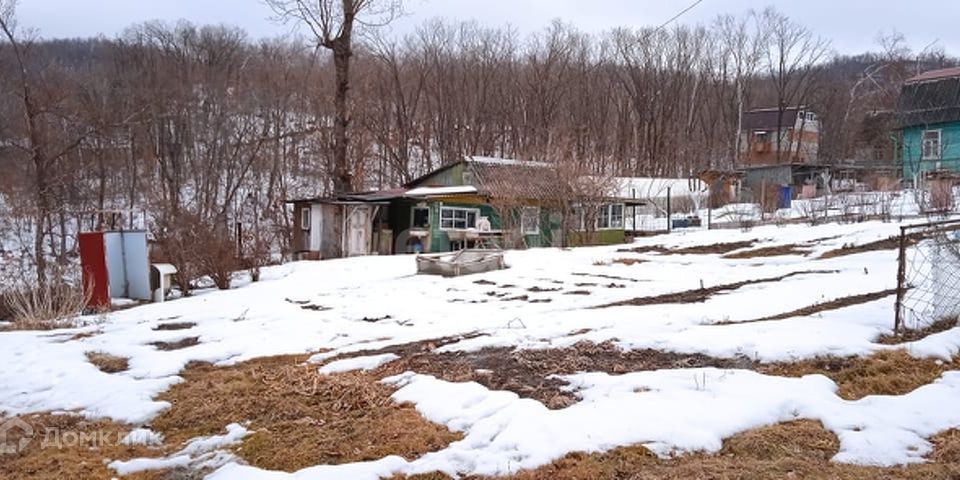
[267,0,402,193]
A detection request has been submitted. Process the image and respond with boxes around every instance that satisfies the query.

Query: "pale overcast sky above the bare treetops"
[18,0,960,55]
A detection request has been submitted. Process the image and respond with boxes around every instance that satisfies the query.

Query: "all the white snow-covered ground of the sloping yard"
[0,222,960,479]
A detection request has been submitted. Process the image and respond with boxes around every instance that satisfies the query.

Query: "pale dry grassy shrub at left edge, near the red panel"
[2,283,89,330]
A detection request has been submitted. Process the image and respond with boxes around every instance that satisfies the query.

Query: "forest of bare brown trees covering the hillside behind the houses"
[0,0,953,290]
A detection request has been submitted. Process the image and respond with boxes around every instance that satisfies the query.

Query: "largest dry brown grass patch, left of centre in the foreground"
[153,356,459,472]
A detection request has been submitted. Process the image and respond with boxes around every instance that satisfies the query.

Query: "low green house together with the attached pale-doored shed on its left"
[288,157,643,258]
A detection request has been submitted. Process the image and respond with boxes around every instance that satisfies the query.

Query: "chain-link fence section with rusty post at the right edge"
[894,220,960,332]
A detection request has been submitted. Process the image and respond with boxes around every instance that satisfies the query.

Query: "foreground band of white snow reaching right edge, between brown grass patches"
[209,368,960,480]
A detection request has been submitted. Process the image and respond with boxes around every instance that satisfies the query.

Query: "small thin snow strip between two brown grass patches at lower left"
[108,423,250,475]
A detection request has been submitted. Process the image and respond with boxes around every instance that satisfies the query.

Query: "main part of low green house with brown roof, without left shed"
[389,157,636,253]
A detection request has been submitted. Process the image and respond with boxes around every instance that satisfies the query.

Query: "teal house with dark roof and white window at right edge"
[897,68,960,185]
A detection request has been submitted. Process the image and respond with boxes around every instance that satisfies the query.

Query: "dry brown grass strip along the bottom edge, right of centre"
[395,420,960,480]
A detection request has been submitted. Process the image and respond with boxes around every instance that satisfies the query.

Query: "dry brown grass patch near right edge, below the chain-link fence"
[758,350,960,400]
